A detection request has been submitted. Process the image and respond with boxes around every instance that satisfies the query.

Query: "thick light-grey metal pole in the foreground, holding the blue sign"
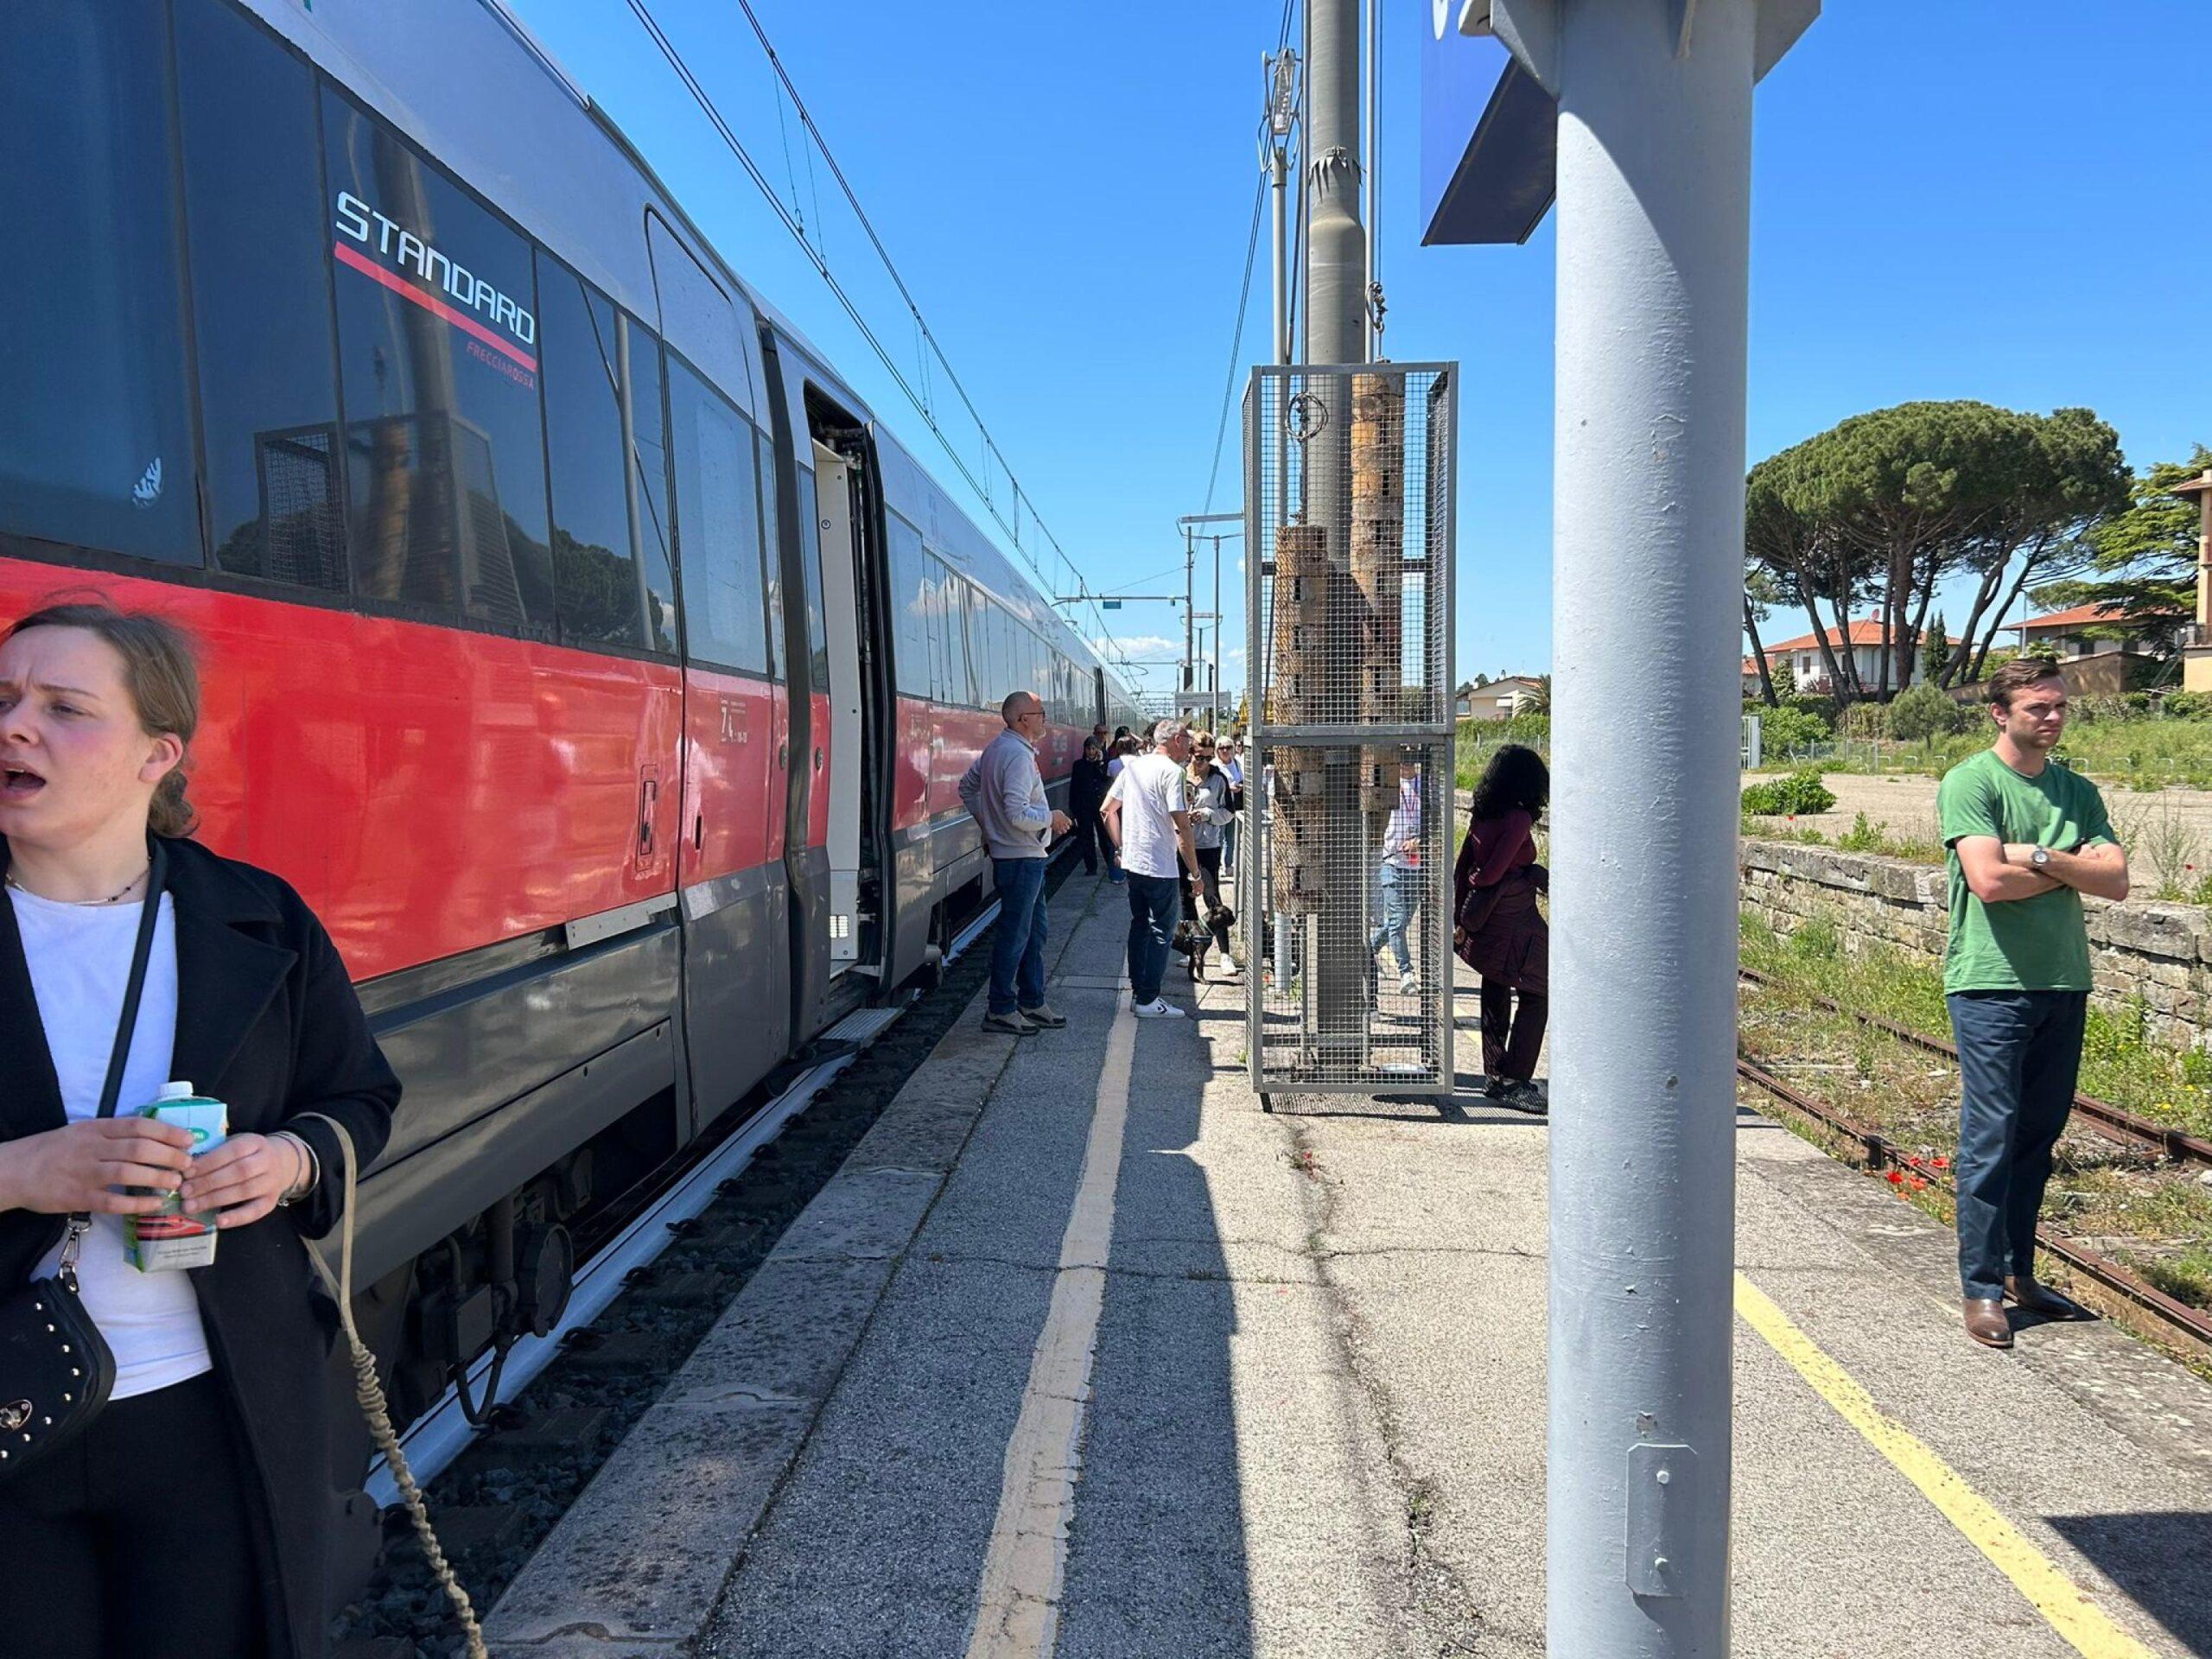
[1491,0,1818,1659]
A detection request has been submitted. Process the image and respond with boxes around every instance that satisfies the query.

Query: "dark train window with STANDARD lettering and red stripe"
[323,86,553,637]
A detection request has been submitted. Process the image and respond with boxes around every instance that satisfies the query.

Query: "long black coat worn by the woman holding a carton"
[0,841,400,1659]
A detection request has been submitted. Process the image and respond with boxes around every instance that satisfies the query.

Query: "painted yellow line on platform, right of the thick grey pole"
[1737,1272,2154,1659]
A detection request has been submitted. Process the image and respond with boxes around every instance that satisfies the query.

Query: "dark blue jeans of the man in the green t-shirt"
[1944,991,2088,1299]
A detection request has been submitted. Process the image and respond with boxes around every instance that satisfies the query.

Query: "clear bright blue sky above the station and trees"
[513,0,2212,703]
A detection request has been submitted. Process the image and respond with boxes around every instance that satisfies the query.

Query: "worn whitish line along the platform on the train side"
[967,991,1137,1659]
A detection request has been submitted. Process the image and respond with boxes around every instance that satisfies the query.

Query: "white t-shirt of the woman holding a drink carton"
[9,887,213,1400]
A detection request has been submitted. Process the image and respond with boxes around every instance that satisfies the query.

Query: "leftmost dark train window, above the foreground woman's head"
[0,0,201,564]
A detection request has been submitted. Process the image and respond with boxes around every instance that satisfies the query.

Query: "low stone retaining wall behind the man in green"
[1743,841,2212,1046]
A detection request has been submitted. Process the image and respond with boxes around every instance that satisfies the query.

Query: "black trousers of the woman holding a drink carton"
[0,1374,274,1659]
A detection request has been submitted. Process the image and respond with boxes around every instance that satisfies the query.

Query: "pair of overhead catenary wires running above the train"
[628,0,1113,664]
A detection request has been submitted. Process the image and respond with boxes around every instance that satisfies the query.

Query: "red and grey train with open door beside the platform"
[0,0,1133,1583]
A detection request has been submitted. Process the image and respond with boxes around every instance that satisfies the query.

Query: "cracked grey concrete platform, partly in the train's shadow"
[489,878,2212,1659]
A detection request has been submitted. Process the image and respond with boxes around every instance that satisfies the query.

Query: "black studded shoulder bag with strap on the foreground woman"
[0,836,168,1484]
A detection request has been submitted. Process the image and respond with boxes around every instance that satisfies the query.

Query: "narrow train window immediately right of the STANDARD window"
[537,254,646,646]
